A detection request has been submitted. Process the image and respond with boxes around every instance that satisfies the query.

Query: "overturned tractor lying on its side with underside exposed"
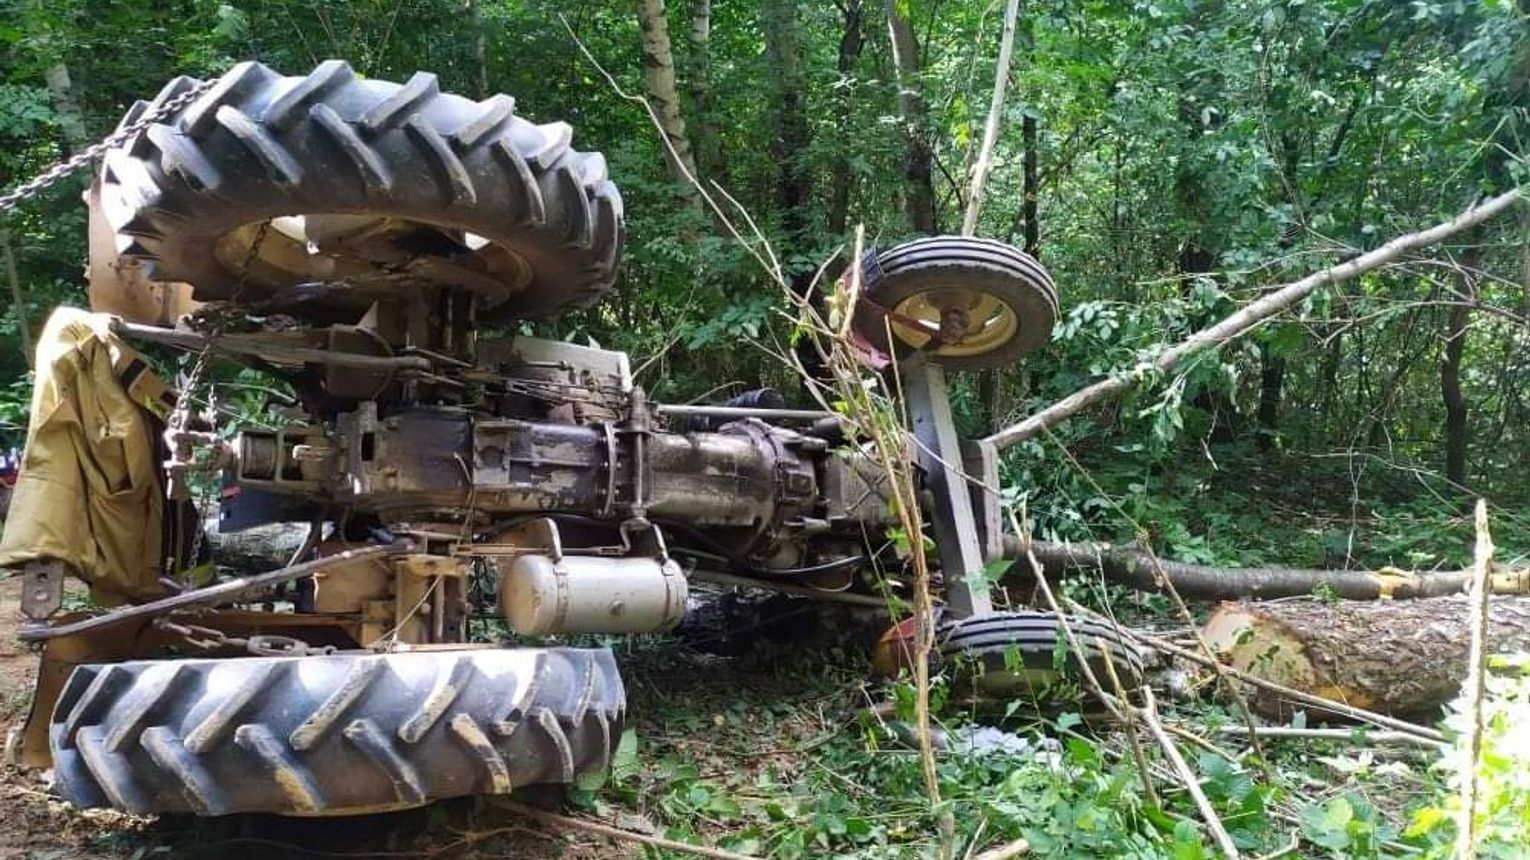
[0,61,1137,814]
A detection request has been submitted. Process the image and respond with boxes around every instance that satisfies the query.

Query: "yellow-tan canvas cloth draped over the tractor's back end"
[0,308,168,603]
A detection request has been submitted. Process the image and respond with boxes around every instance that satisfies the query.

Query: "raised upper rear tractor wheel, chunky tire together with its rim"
[101,60,623,320]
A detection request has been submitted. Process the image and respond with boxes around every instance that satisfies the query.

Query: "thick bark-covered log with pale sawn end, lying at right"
[1201,595,1530,718]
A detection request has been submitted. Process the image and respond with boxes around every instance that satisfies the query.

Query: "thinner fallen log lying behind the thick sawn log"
[1004,536,1530,600]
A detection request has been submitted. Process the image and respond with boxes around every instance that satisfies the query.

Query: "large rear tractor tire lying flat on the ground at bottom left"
[49,649,626,816]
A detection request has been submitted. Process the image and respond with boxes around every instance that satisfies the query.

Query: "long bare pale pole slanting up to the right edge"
[984,188,1525,448]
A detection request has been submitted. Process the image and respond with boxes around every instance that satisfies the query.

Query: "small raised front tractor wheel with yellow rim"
[854,236,1057,370]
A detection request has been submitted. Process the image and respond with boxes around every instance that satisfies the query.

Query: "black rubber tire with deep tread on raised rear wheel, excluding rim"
[103,60,624,321]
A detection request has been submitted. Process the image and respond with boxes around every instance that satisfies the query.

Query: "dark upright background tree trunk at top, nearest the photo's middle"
[763,0,812,249]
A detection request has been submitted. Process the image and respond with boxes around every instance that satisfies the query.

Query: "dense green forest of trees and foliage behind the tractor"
[0,0,1530,568]
